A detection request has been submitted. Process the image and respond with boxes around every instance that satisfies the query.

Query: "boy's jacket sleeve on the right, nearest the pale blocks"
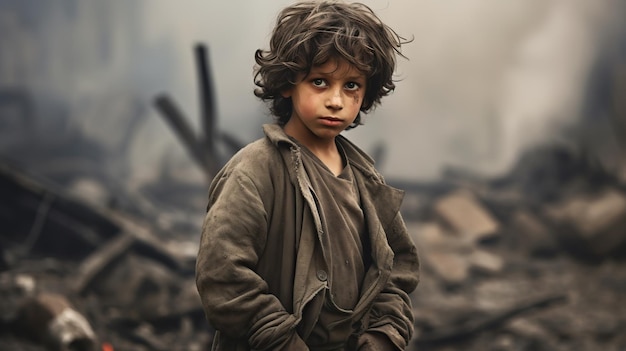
[361,213,420,350]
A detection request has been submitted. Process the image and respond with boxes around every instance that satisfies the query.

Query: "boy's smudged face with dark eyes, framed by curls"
[283,59,367,148]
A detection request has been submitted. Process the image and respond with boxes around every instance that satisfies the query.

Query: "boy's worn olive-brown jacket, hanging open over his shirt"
[196,125,419,351]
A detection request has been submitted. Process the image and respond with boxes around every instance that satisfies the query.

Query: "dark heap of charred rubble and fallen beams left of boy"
[0,164,212,351]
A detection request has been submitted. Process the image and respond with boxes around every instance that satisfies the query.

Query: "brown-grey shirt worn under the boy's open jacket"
[302,142,370,350]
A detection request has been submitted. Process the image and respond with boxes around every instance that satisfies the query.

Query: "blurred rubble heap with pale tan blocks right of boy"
[408,146,626,351]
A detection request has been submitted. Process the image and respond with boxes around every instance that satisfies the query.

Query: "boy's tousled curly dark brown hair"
[254,1,410,128]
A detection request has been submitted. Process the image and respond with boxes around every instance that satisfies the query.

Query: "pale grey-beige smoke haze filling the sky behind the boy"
[0,0,626,184]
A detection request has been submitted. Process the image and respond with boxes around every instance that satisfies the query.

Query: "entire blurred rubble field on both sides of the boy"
[0,141,626,351]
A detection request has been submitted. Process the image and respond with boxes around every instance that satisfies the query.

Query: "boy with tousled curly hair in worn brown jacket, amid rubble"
[196,1,419,351]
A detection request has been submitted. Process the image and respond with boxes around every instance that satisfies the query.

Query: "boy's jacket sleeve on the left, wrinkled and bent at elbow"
[196,171,307,350]
